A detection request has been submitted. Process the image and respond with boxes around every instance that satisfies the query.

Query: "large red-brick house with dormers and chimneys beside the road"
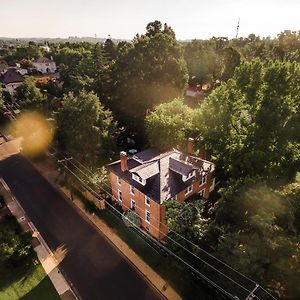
[108,139,215,239]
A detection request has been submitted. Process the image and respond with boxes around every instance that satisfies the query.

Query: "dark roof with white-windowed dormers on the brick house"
[108,148,215,204]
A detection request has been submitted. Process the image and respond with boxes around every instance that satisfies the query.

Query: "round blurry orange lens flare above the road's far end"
[8,112,53,157]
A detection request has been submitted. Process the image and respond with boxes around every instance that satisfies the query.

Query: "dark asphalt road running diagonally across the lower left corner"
[0,155,161,300]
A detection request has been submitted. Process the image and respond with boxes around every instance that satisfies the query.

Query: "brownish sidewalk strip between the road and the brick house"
[33,158,181,300]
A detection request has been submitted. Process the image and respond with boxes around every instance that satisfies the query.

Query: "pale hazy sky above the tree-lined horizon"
[0,0,300,39]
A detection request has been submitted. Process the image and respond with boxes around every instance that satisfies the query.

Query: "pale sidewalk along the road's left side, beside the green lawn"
[0,178,78,300]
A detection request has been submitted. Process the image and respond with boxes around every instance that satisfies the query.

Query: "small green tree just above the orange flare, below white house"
[16,77,46,109]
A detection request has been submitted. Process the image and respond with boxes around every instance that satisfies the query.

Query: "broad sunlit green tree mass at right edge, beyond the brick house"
[194,60,300,180]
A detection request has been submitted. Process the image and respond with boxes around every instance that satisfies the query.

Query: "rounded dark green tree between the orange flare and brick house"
[56,91,118,166]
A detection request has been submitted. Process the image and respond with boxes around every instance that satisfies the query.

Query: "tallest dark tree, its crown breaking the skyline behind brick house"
[110,21,187,137]
